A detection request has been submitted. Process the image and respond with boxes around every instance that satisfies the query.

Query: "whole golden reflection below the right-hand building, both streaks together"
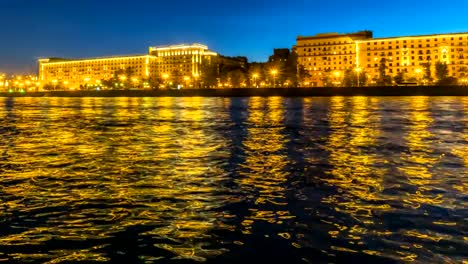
[322,97,466,261]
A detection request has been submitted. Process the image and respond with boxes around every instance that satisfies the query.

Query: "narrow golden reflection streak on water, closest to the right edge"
[399,97,442,208]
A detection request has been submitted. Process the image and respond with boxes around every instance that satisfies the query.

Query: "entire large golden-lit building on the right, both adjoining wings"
[294,31,468,86]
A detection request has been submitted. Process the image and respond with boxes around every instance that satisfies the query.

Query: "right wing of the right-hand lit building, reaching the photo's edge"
[356,33,468,83]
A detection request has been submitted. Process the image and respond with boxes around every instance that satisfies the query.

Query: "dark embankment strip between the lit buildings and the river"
[0,86,468,97]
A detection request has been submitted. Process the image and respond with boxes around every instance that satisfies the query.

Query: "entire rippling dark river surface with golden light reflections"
[0,97,468,263]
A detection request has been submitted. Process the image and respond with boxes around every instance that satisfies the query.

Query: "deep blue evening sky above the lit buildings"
[0,0,468,72]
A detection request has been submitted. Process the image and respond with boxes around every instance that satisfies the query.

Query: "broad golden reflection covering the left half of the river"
[0,98,228,262]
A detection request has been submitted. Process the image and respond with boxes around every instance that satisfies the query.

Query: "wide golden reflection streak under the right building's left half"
[322,97,390,254]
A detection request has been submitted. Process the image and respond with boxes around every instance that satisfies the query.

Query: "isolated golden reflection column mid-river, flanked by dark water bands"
[238,97,293,234]
